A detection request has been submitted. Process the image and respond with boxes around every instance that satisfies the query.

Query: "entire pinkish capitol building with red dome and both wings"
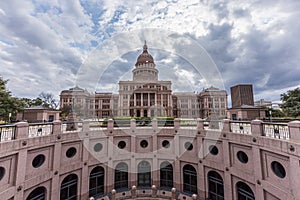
[60,43,227,119]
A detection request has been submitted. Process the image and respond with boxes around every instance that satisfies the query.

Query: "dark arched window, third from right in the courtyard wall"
[183,165,197,194]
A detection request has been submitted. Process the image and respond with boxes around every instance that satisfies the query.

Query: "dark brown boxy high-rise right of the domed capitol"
[230,84,254,108]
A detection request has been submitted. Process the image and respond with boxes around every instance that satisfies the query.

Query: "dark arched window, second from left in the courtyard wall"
[60,174,78,200]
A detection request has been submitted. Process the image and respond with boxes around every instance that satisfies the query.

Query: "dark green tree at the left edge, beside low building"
[0,77,24,122]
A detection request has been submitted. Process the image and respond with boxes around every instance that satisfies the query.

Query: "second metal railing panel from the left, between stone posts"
[28,123,53,137]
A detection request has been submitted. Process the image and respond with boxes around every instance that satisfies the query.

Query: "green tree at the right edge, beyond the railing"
[280,87,300,117]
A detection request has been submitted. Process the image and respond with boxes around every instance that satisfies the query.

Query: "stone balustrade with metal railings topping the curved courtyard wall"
[0,118,300,142]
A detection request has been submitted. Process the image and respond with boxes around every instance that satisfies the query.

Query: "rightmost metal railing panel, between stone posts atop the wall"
[262,122,290,140]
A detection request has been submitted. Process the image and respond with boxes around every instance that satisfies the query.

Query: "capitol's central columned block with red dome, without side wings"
[118,42,173,117]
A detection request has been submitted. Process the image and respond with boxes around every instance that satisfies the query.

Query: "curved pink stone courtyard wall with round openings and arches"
[0,119,300,200]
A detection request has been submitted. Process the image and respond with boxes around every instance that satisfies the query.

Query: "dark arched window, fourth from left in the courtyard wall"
[115,162,128,190]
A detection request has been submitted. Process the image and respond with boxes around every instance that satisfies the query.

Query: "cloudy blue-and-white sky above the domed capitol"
[0,0,300,103]
